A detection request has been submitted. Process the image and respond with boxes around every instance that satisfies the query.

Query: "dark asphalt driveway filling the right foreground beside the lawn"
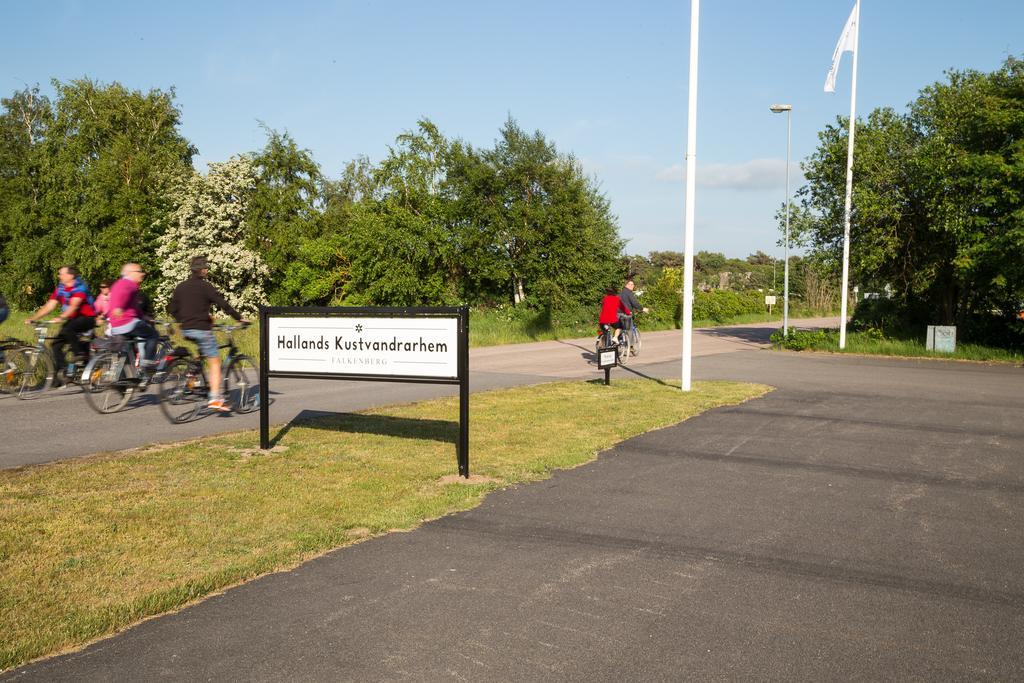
[4,351,1024,681]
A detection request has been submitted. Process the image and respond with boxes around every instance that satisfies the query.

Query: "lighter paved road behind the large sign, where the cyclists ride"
[0,318,838,468]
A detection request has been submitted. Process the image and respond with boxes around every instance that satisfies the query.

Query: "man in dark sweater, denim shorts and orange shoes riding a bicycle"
[167,256,249,413]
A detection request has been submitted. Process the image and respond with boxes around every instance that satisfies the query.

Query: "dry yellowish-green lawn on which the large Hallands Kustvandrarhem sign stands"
[0,380,769,670]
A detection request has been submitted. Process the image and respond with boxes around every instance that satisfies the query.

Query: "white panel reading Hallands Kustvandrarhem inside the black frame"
[267,315,459,379]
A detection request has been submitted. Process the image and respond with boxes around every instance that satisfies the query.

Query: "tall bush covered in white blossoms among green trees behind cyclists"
[156,156,270,315]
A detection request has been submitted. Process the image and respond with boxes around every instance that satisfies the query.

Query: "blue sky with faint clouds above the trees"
[0,0,1024,256]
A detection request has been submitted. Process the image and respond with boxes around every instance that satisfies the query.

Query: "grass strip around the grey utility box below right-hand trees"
[772,330,1024,364]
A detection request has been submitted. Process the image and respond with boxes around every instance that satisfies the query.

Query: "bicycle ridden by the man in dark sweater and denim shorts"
[160,324,259,424]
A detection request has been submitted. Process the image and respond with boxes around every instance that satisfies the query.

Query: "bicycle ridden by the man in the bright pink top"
[82,321,180,414]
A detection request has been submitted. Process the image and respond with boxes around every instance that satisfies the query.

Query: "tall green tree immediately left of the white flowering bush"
[41,79,195,294]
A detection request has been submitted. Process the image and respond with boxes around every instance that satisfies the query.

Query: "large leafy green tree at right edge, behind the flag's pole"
[794,58,1024,337]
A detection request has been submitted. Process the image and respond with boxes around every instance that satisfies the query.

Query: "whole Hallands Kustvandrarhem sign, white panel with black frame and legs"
[259,306,469,477]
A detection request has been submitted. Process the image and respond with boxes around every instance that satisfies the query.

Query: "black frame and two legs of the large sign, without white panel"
[259,306,469,478]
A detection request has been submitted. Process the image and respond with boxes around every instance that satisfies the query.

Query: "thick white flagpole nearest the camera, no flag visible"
[681,0,700,391]
